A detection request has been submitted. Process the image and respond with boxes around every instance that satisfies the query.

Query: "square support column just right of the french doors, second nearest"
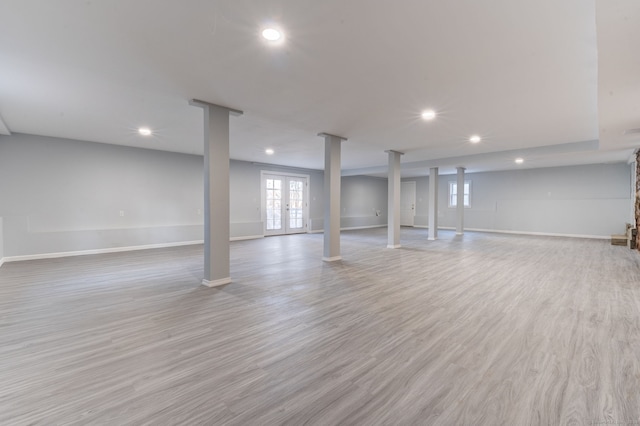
[318,133,347,262]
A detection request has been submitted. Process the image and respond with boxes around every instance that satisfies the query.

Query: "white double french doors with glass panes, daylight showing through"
[262,172,309,235]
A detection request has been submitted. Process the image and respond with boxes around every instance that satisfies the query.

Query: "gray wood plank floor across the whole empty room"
[0,229,640,425]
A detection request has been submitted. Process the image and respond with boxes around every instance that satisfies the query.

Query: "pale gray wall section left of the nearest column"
[0,134,203,257]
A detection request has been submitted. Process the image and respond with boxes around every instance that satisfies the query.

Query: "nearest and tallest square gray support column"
[189,99,242,287]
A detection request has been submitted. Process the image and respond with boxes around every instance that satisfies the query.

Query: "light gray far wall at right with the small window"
[404,164,631,237]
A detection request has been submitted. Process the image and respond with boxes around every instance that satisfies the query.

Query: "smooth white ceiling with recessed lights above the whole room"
[0,0,640,176]
